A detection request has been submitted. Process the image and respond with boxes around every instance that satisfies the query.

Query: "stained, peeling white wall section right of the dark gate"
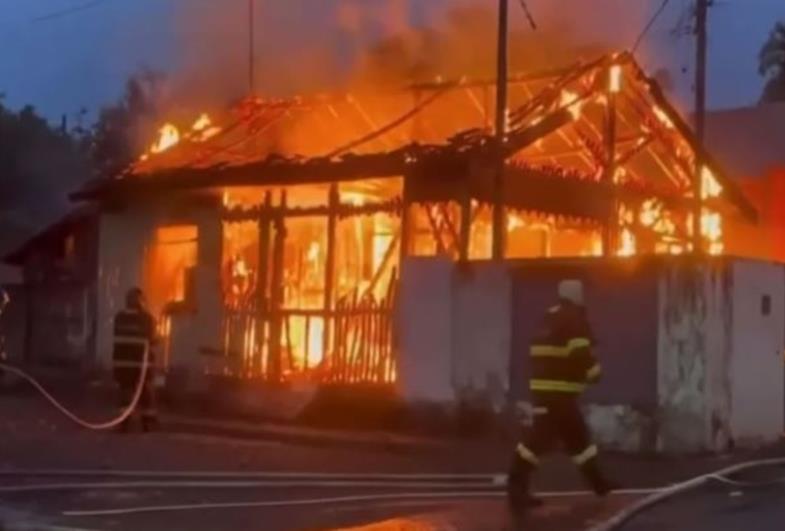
[657,260,731,452]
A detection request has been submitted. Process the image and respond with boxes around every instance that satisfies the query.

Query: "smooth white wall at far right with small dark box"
[730,260,785,446]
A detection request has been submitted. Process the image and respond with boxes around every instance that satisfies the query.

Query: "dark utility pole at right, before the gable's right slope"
[692,0,711,254]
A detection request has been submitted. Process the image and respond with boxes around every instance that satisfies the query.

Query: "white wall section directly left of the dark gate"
[452,263,512,411]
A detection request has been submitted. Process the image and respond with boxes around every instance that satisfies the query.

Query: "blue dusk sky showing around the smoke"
[0,0,785,119]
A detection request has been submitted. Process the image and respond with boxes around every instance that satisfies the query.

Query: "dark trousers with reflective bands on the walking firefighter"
[508,396,610,503]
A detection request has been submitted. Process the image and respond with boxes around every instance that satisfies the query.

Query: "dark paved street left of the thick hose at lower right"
[0,395,780,531]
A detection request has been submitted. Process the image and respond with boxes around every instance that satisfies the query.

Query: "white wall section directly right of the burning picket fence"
[396,258,455,402]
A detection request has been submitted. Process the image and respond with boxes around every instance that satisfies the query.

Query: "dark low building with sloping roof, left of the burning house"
[5,206,98,366]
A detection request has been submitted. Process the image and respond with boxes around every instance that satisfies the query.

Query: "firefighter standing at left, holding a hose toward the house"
[112,288,158,431]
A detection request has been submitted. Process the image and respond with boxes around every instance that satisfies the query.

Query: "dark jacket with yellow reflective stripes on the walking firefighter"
[529,301,601,397]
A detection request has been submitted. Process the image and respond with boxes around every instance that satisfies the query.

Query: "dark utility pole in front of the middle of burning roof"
[492,0,509,260]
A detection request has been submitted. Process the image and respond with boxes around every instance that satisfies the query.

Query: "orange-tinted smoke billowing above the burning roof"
[165,0,649,108]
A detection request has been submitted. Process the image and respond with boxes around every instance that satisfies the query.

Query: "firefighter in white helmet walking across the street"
[507,280,611,512]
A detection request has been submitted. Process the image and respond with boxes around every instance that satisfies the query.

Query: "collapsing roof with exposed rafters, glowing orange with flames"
[74,49,755,224]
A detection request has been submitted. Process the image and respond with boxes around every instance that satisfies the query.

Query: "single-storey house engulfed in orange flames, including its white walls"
[7,54,785,449]
